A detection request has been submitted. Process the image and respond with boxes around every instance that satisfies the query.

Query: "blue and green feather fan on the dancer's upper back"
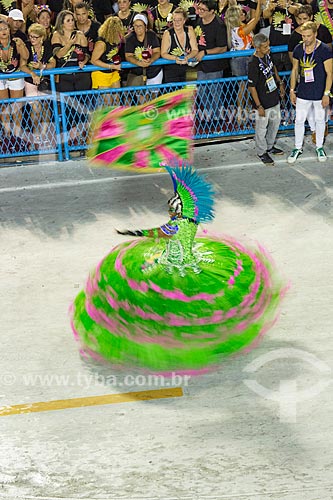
[165,165,215,222]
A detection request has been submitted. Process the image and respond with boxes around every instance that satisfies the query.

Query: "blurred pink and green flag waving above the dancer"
[88,87,193,173]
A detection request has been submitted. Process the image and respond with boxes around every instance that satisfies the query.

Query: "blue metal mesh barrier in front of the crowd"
[0,46,294,161]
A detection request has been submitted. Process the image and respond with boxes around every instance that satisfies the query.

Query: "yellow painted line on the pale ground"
[0,387,183,417]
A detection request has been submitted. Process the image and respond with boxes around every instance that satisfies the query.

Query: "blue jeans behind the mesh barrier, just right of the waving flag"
[197,70,223,121]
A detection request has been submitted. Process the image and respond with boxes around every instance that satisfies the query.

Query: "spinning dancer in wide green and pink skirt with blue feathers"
[72,165,282,374]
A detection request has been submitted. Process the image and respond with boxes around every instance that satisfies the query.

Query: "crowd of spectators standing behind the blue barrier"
[0,0,333,149]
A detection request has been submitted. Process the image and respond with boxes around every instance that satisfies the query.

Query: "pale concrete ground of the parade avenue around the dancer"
[0,136,333,500]
